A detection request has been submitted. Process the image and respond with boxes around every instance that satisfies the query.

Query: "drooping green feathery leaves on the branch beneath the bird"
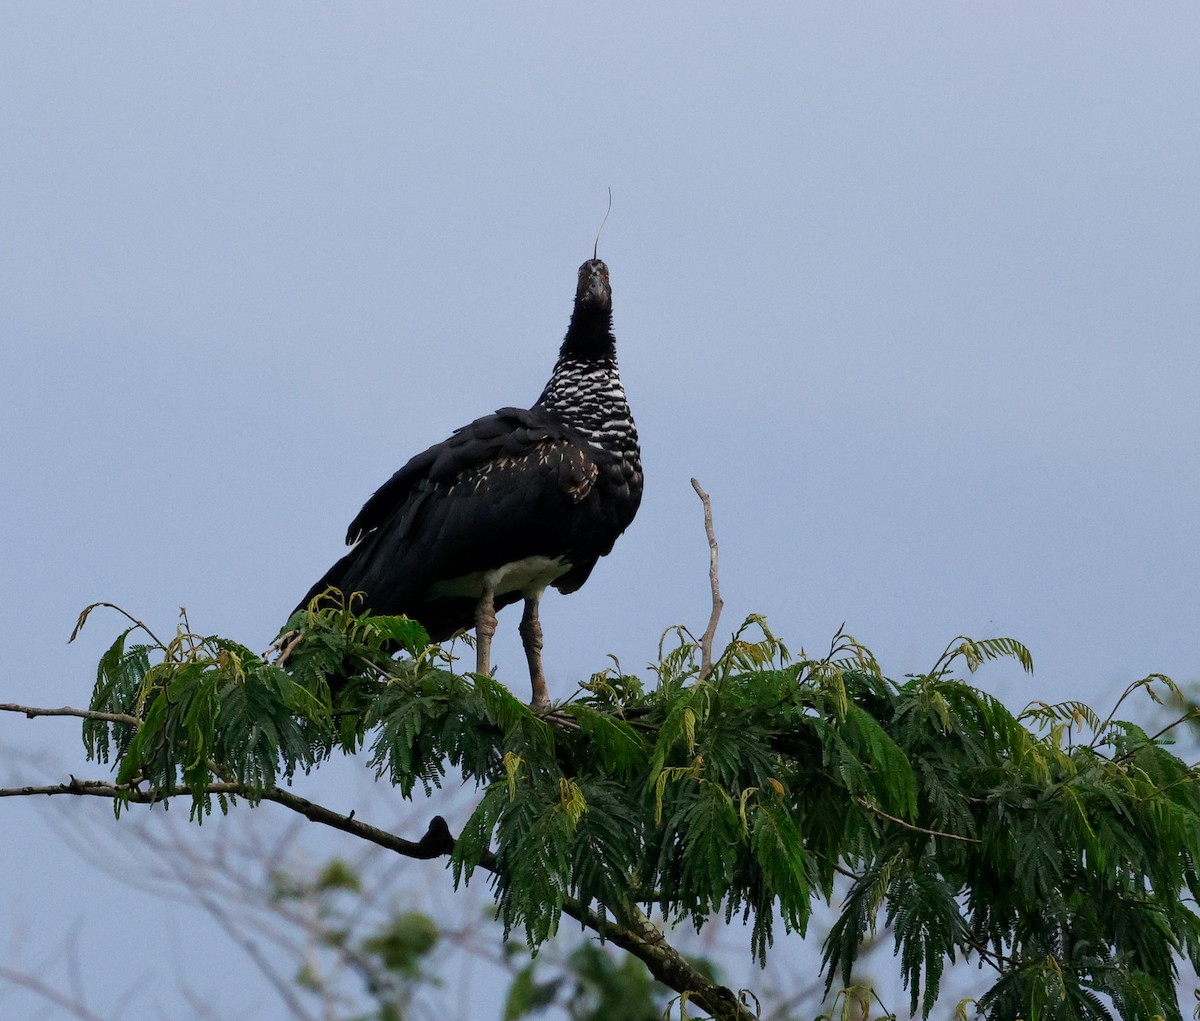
[72,599,1200,1021]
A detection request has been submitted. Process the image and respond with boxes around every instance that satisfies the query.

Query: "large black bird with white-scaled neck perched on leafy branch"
[300,258,642,707]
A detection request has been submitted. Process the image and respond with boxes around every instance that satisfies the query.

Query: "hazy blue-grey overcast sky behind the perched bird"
[0,2,1200,1017]
